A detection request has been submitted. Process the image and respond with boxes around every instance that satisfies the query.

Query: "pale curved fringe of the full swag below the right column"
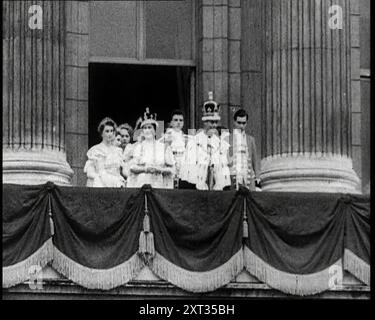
[244,246,341,296]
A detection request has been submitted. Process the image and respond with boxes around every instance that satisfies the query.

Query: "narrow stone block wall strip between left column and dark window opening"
[65,1,89,186]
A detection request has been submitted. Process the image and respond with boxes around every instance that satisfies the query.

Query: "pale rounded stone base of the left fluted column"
[3,149,73,185]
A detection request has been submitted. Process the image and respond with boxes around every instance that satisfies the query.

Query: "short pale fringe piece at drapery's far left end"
[3,238,53,288]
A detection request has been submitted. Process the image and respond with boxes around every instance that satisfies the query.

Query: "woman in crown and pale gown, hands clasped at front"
[130,108,175,189]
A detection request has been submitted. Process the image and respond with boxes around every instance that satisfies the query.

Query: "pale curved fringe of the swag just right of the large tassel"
[150,249,243,292]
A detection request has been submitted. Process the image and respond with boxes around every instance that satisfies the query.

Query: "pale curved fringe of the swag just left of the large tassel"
[52,247,144,290]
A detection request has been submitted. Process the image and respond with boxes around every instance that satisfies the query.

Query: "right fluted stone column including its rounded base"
[261,0,359,193]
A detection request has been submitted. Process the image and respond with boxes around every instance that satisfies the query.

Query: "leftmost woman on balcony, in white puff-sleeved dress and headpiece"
[84,118,125,188]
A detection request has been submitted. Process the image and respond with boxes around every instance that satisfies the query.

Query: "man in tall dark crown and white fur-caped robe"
[181,92,231,190]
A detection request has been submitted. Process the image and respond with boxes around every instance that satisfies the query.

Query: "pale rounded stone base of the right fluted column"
[260,153,361,194]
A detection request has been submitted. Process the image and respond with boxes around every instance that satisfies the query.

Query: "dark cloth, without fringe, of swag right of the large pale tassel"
[148,190,243,272]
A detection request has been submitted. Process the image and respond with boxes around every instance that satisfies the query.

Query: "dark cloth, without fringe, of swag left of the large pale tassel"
[52,187,144,269]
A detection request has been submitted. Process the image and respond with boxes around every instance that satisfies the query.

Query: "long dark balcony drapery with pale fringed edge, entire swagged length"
[3,183,370,295]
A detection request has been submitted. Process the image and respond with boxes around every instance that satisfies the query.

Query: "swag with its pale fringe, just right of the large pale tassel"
[143,190,243,292]
